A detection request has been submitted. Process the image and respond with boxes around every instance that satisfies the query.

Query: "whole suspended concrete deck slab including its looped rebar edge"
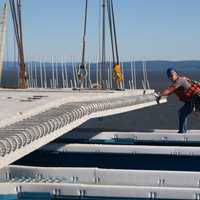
[0,90,166,168]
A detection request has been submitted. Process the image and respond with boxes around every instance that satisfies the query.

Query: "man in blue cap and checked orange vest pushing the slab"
[158,68,200,133]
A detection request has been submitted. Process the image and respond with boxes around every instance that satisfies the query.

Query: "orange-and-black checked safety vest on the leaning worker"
[175,79,200,102]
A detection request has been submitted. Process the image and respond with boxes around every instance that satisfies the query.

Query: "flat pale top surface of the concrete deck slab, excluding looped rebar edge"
[0,89,153,127]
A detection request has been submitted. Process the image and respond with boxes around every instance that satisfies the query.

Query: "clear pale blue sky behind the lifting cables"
[3,0,200,61]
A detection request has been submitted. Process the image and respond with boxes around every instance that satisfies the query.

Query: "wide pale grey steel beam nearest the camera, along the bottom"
[0,166,200,199]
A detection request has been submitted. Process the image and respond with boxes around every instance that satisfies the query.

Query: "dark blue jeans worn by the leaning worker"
[178,102,193,133]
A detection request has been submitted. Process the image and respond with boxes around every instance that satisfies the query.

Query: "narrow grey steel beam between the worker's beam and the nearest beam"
[41,143,200,156]
